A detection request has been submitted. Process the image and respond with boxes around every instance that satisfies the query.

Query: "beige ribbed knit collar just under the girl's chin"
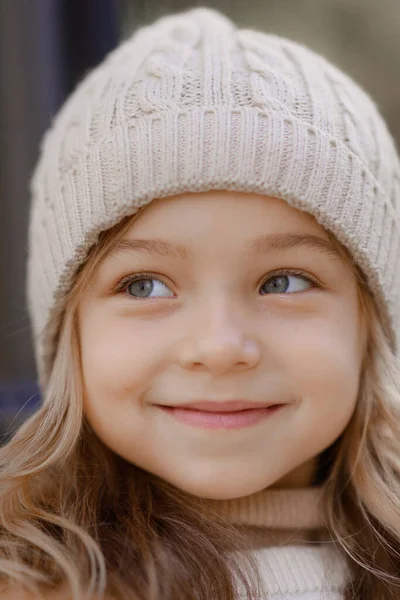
[203,486,324,530]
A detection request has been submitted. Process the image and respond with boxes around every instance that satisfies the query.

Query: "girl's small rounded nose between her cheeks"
[179,306,261,375]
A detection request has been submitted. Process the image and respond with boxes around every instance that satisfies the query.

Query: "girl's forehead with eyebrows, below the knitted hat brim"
[98,191,349,270]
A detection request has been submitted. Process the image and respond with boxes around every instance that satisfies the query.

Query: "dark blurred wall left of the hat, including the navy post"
[0,0,119,384]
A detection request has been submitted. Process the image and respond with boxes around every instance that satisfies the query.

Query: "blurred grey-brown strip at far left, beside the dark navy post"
[0,0,66,380]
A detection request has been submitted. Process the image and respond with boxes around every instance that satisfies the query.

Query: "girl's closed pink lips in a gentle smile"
[158,401,286,429]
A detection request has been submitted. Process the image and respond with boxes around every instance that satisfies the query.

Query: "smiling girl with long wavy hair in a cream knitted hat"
[0,8,400,600]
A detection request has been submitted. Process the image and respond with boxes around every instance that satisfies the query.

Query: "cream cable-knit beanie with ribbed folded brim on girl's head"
[28,8,400,386]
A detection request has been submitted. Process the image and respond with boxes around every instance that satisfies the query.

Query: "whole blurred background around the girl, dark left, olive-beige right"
[0,0,400,444]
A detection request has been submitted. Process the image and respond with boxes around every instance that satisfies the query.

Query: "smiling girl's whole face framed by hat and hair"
[79,192,365,499]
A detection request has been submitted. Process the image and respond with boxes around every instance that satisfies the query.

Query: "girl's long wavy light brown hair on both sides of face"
[0,215,400,600]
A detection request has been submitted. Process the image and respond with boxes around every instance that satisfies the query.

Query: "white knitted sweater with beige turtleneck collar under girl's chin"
[208,487,348,600]
